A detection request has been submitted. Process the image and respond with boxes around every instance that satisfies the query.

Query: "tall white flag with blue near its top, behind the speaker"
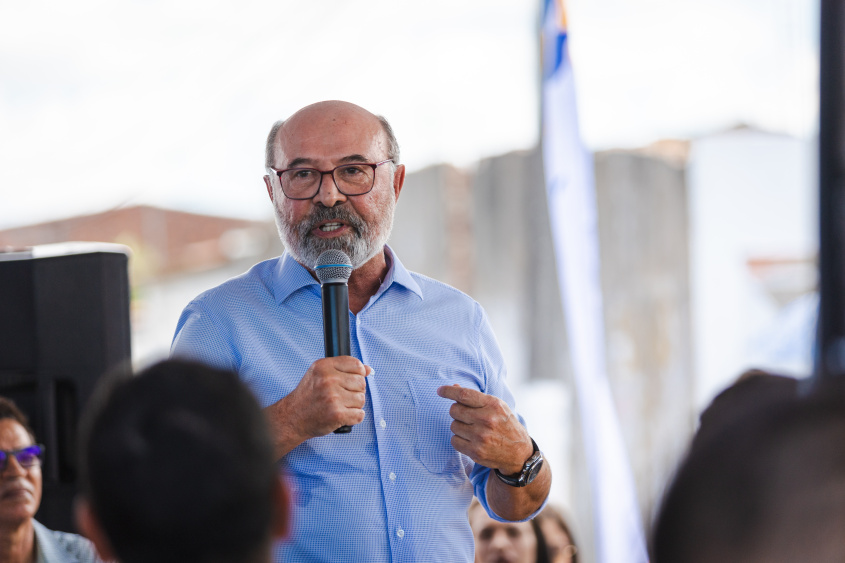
[543,0,648,563]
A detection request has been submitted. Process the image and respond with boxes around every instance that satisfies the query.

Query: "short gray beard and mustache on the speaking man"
[273,194,396,270]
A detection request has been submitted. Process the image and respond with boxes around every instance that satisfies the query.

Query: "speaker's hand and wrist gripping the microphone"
[264,356,372,458]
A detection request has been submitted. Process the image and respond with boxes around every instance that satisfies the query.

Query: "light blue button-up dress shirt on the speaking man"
[172,247,536,563]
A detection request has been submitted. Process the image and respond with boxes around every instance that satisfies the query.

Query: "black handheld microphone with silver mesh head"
[314,249,352,434]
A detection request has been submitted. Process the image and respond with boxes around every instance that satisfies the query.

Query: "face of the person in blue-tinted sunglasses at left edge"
[0,418,41,526]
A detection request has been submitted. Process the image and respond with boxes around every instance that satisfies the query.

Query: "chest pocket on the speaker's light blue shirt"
[408,379,473,475]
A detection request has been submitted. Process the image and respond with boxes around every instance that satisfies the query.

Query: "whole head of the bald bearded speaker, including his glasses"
[264,101,405,269]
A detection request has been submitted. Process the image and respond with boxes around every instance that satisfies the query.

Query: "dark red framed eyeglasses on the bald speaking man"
[272,158,393,199]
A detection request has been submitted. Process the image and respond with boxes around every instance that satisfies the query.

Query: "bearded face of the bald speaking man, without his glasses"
[267,102,402,268]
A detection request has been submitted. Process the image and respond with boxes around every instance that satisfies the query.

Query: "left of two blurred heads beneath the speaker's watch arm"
[468,499,549,563]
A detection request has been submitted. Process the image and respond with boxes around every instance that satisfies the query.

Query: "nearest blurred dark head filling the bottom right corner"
[651,374,845,563]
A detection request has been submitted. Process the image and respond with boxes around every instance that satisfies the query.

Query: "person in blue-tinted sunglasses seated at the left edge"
[0,397,98,563]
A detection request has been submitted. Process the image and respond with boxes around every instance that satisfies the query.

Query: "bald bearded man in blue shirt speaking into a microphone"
[172,101,551,563]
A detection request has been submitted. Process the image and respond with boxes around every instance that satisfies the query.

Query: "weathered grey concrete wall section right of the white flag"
[595,151,694,519]
